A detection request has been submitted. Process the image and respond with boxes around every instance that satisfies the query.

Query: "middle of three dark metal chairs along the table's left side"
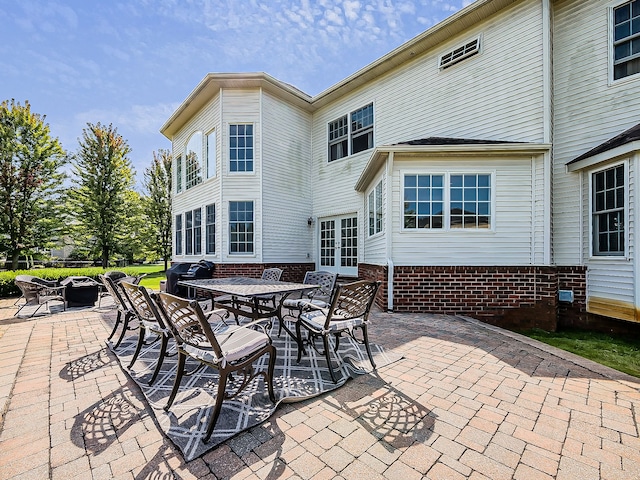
[120,281,173,385]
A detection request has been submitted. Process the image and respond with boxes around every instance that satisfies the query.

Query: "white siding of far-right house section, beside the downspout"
[553,0,640,265]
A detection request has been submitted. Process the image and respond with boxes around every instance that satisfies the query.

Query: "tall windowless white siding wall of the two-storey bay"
[262,93,314,262]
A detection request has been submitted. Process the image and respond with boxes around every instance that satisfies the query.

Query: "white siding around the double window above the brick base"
[393,158,542,265]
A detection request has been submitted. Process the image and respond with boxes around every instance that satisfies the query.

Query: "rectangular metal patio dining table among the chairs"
[178,277,318,341]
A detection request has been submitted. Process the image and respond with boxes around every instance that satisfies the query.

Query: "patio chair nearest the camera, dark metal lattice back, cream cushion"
[158,292,276,443]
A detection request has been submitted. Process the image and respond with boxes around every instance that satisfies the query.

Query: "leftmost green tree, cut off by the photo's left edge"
[0,100,66,270]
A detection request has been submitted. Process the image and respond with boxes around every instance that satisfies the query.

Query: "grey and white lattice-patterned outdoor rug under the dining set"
[114,321,402,461]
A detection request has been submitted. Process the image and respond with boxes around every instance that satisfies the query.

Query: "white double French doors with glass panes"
[319,215,358,276]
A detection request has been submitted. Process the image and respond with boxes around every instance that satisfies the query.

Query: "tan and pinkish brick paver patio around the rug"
[0,300,640,480]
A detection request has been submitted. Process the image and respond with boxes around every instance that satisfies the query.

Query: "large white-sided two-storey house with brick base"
[161,0,640,328]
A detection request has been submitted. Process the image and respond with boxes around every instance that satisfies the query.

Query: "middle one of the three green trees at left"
[69,123,134,268]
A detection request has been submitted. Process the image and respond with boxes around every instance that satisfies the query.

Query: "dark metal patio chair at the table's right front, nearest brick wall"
[296,280,380,383]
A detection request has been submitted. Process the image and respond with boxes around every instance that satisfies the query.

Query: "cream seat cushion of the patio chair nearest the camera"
[182,325,269,365]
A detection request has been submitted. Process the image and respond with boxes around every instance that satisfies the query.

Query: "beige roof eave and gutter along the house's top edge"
[160,0,520,140]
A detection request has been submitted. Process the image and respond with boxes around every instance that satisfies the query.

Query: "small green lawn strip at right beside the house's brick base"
[520,330,640,377]
